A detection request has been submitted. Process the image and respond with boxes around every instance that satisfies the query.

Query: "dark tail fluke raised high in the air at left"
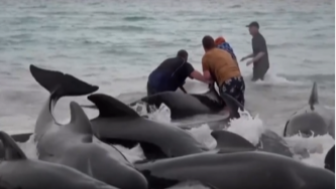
[29,65,99,98]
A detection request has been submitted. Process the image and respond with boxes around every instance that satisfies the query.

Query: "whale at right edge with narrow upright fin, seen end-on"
[283,82,335,138]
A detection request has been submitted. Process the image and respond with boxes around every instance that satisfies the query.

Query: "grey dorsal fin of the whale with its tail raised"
[67,102,93,142]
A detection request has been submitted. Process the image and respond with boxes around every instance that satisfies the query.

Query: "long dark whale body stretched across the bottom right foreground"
[135,140,335,189]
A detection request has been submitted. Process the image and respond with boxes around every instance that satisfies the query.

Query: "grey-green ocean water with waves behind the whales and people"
[0,0,335,188]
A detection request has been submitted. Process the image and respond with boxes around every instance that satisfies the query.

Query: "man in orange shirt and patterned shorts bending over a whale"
[202,36,245,106]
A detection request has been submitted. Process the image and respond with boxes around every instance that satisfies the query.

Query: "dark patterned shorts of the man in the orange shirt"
[219,77,245,106]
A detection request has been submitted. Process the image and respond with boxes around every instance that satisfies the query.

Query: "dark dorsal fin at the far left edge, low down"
[0,131,27,160]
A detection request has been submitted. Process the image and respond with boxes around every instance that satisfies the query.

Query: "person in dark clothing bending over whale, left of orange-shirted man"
[147,50,209,96]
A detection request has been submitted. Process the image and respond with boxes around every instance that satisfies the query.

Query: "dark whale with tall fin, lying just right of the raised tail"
[88,94,206,159]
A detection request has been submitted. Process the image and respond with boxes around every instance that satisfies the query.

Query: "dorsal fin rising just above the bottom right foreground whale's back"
[211,131,256,153]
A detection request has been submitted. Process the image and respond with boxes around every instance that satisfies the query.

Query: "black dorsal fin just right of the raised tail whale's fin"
[88,94,140,117]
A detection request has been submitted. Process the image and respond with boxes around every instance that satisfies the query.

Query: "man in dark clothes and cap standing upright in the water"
[241,22,269,81]
